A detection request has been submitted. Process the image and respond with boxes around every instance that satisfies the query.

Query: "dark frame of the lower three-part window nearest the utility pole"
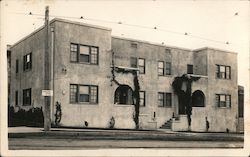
[69,83,99,105]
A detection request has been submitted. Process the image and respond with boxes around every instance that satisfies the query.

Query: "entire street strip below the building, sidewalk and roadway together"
[8,127,244,150]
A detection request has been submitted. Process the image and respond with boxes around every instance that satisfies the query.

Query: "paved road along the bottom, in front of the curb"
[9,137,243,150]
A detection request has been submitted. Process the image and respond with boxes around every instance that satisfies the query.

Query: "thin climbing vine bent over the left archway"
[111,51,140,130]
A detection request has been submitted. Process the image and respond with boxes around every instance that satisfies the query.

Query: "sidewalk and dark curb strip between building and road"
[8,127,244,141]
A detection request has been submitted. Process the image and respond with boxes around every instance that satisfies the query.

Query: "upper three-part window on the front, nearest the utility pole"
[70,44,99,64]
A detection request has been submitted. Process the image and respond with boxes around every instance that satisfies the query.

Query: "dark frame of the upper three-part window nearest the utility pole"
[70,43,99,65]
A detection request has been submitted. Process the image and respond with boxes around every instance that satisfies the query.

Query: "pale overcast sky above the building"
[2,0,250,102]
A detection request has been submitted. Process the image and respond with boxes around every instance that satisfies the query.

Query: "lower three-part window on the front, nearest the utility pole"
[70,84,98,104]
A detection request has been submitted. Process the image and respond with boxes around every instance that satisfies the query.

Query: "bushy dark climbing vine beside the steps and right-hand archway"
[172,74,200,127]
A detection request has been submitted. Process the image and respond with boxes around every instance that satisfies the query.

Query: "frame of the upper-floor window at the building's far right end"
[215,64,232,80]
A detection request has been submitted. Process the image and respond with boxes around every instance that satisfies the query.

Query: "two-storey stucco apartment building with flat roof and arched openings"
[10,19,239,132]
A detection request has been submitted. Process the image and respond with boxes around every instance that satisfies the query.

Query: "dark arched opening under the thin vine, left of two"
[114,85,134,105]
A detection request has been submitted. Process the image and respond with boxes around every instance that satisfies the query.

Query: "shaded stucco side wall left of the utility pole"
[10,26,44,110]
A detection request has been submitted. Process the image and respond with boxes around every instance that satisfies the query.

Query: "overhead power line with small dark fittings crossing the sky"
[8,12,247,45]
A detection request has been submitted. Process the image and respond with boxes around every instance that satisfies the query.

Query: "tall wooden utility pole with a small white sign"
[43,6,51,131]
